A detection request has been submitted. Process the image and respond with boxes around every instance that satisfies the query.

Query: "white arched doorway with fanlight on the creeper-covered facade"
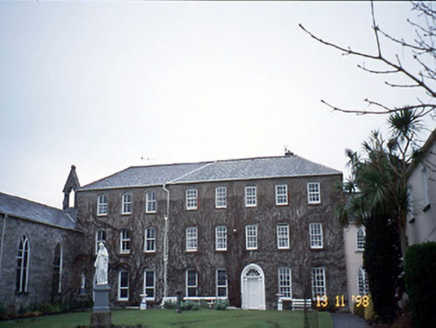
[241,264,266,310]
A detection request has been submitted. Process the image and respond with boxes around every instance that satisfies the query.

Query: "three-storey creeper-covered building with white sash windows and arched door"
[75,153,347,309]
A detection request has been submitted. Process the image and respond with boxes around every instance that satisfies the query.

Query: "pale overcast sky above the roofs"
[0,1,434,207]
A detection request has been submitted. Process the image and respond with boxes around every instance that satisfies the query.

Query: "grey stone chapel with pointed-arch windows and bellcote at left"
[0,170,83,312]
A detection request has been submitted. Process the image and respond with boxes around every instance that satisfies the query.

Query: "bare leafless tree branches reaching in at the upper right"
[299,1,436,117]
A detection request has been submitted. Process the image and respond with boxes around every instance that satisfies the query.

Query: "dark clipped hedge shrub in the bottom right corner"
[405,242,436,327]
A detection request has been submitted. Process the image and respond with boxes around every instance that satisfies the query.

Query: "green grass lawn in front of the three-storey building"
[0,309,333,328]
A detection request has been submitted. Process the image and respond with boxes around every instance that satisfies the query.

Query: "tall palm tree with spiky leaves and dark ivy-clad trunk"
[339,110,421,323]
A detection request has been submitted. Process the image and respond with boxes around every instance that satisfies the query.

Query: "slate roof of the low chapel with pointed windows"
[0,192,76,229]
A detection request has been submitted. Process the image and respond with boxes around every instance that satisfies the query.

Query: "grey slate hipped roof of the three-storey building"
[79,155,342,190]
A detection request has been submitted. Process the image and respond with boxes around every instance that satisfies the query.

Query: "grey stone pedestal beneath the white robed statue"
[91,285,111,328]
